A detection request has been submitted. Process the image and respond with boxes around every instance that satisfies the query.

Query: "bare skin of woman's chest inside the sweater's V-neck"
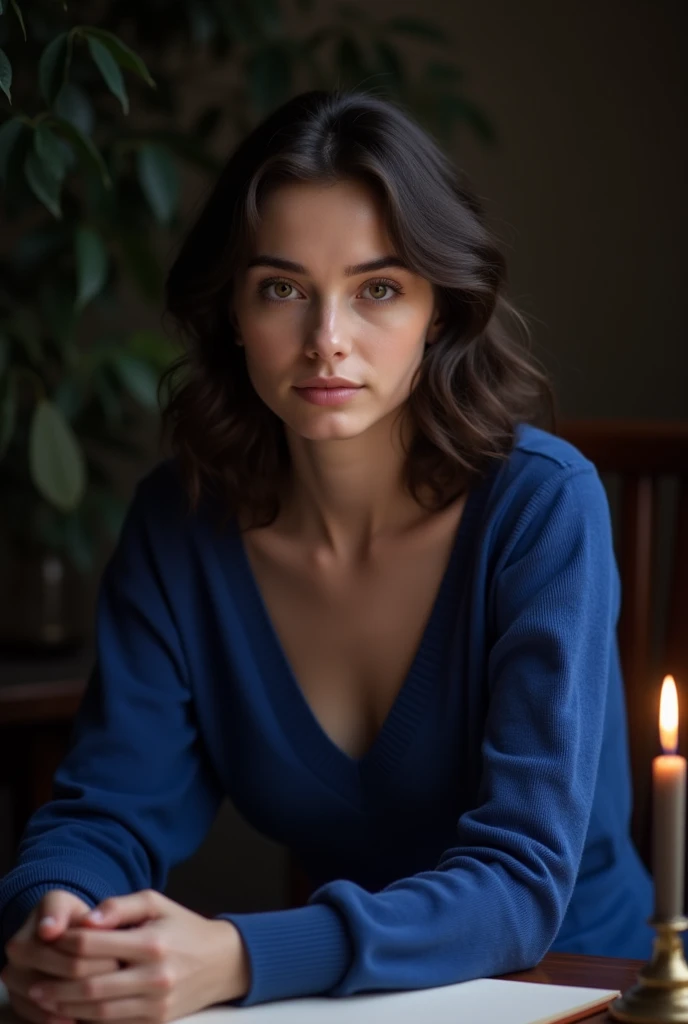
[239,497,465,758]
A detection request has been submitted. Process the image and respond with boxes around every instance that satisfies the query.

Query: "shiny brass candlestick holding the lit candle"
[609,915,688,1024]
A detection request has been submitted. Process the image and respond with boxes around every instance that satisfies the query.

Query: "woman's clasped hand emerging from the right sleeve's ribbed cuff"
[19,890,249,1024]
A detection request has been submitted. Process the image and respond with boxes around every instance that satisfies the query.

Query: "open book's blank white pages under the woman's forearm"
[0,978,618,1024]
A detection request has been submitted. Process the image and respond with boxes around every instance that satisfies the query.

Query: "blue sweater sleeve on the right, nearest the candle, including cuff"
[219,462,619,1005]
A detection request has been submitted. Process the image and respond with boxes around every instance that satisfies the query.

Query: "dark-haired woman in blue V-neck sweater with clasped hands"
[0,92,651,1022]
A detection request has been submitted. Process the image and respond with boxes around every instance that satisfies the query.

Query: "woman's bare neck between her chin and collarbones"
[280,407,421,562]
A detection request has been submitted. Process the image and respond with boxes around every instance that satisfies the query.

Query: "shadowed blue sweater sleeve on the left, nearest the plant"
[0,475,222,965]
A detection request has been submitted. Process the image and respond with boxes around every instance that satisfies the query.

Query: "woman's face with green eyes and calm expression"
[232,181,437,440]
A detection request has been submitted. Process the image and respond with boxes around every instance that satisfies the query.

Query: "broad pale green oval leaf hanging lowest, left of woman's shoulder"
[29,398,86,512]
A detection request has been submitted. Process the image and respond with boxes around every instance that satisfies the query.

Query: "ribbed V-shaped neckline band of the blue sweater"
[231,483,481,800]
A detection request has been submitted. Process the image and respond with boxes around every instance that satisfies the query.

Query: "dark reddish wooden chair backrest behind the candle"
[557,420,688,868]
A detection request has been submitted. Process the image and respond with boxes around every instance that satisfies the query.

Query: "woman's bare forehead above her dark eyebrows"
[253,181,393,253]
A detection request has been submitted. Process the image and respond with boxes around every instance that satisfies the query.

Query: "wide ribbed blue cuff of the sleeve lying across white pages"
[216,903,352,1007]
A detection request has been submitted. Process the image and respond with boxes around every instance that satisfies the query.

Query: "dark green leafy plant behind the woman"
[0,0,492,569]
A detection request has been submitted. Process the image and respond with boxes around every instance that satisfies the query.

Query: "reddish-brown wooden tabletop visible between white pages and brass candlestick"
[503,953,643,1024]
